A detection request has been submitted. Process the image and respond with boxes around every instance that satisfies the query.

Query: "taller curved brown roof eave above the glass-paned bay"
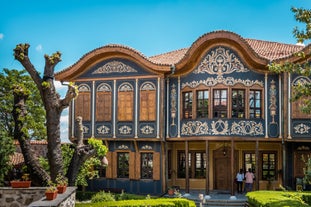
[175,30,270,73]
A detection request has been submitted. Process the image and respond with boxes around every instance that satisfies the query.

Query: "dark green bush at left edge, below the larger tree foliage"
[0,130,15,186]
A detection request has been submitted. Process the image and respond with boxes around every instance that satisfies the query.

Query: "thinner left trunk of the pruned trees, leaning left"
[13,86,50,186]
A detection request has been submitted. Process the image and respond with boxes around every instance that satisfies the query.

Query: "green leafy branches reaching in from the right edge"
[268,7,311,113]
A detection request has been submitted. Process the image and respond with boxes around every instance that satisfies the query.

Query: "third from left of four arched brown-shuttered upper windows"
[118,83,134,121]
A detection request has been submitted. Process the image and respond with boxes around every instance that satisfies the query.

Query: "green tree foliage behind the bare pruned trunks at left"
[0,69,46,140]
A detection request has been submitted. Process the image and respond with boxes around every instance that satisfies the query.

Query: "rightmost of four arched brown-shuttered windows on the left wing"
[139,82,157,121]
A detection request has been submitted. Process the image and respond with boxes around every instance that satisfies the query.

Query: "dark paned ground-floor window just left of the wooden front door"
[177,151,206,178]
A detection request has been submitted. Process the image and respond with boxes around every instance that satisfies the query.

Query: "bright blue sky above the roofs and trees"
[0,0,311,141]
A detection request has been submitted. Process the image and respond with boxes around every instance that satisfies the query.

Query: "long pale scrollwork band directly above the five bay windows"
[181,77,264,89]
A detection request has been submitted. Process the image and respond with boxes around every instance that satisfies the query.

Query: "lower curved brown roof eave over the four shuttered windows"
[55,44,170,81]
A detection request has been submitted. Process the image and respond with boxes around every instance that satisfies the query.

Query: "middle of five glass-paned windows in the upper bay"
[213,89,228,118]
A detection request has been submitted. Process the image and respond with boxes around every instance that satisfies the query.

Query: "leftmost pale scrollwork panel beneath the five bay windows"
[181,121,208,135]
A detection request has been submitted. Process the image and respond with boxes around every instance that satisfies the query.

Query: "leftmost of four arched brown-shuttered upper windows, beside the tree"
[75,84,91,121]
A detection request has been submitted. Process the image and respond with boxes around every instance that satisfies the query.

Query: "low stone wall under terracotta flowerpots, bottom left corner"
[0,187,76,207]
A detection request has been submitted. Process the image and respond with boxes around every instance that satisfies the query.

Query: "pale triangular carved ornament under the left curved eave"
[92,60,137,74]
